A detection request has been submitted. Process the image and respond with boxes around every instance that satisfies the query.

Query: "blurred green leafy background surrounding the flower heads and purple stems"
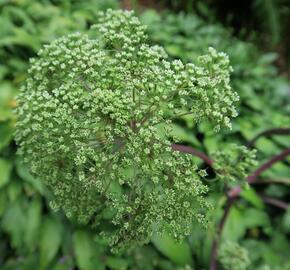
[0,0,290,270]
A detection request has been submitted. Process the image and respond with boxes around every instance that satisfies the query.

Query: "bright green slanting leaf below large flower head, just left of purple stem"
[152,235,192,266]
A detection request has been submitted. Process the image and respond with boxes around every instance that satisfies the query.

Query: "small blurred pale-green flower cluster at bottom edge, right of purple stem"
[219,241,251,270]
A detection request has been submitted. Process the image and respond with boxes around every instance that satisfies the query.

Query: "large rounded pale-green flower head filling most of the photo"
[16,10,238,248]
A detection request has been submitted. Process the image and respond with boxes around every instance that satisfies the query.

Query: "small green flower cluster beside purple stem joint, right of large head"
[212,144,257,184]
